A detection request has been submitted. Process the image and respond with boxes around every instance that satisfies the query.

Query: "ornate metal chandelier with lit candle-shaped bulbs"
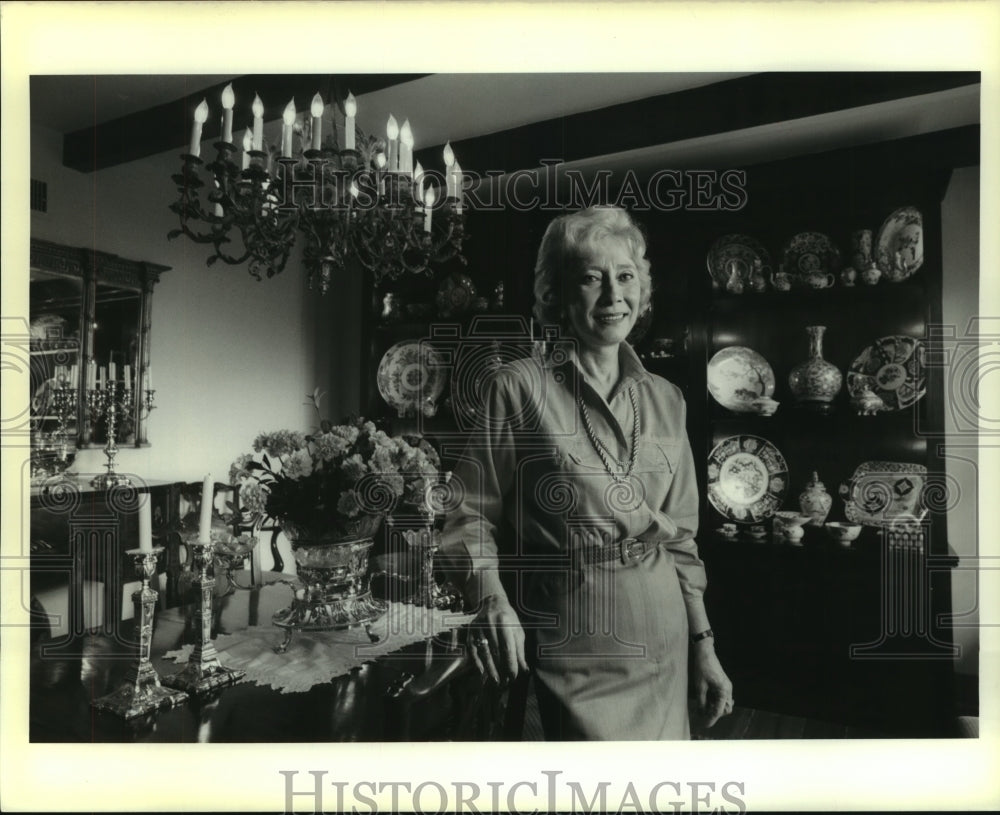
[167,84,466,293]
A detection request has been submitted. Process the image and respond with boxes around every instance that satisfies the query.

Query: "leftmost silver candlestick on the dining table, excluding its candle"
[91,546,187,719]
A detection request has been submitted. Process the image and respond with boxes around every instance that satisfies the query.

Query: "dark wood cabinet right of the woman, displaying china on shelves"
[639,129,978,736]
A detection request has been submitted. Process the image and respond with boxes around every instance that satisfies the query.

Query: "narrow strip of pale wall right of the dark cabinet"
[941,167,991,688]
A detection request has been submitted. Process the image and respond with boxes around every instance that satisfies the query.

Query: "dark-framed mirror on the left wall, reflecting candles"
[29,239,168,478]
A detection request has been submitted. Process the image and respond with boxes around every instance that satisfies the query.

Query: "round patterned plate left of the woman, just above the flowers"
[376,340,447,418]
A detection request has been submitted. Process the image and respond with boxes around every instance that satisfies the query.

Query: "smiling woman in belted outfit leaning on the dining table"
[442,207,733,740]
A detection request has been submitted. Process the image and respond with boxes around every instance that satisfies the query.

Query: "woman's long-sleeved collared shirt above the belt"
[441,343,709,631]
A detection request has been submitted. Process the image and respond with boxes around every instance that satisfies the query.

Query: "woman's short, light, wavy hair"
[534,206,653,325]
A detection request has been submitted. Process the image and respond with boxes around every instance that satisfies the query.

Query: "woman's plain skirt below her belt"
[524,547,690,741]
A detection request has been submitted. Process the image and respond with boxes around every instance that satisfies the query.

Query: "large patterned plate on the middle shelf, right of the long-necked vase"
[847,335,927,410]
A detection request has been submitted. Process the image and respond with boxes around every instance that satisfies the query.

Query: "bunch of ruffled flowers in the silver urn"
[229,394,440,536]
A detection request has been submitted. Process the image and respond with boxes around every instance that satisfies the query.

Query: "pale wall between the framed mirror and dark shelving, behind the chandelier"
[31,127,360,488]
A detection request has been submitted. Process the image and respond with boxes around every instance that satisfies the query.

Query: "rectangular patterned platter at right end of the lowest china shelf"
[840,461,927,526]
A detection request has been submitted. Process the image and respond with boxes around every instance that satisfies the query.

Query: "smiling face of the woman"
[565,238,642,350]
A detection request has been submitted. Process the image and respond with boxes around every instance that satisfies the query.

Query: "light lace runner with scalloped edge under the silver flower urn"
[164,603,473,693]
